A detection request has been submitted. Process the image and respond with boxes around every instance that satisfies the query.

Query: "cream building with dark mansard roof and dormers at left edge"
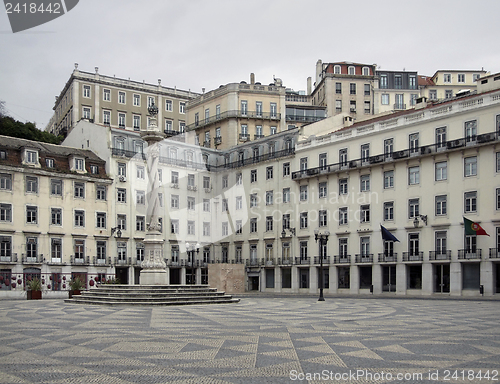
[0,136,114,296]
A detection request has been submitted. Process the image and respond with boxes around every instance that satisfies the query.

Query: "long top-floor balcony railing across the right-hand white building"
[292,132,500,180]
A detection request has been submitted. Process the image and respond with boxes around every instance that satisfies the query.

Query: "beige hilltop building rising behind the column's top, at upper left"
[45,64,198,136]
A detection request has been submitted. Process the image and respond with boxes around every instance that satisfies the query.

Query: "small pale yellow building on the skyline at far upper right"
[422,69,489,100]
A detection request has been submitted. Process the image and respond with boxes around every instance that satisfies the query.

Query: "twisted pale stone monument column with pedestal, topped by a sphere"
[140,104,168,285]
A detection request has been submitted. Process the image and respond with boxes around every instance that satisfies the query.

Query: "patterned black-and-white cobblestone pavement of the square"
[0,297,500,384]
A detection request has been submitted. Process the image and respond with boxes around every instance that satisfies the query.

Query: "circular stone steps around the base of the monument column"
[64,284,240,305]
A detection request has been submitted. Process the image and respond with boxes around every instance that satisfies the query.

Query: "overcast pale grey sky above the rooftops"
[0,0,500,129]
